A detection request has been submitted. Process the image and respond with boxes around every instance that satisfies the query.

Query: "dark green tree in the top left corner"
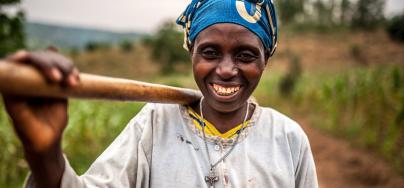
[0,0,25,58]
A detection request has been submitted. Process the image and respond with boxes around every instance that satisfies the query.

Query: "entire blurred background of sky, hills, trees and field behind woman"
[0,0,404,188]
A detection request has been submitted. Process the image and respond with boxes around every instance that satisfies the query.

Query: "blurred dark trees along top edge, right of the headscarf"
[277,0,385,31]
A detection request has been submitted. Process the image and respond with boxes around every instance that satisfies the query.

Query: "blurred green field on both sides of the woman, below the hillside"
[0,62,404,187]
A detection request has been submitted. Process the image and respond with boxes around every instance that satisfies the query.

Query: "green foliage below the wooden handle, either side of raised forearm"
[0,100,143,187]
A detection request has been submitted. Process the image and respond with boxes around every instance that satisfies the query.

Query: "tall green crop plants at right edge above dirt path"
[301,65,404,174]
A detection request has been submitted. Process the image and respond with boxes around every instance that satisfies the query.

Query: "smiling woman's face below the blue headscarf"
[192,23,268,112]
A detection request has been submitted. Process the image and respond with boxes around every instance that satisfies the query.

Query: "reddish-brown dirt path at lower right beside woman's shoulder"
[300,122,404,188]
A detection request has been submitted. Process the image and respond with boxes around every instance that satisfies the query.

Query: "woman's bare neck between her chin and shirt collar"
[191,101,255,133]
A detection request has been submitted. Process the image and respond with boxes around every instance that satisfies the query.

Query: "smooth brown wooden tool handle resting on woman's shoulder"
[0,61,201,104]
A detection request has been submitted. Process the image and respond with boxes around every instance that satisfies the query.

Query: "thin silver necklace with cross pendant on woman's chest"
[199,97,250,188]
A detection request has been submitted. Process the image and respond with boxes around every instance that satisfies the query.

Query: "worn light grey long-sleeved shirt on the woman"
[25,103,318,188]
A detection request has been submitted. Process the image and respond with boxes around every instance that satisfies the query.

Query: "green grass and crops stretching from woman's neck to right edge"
[254,65,404,175]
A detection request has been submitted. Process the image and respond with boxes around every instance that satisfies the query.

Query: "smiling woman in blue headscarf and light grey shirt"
[4,0,317,187]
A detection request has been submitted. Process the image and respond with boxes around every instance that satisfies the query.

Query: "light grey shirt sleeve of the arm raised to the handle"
[25,105,153,188]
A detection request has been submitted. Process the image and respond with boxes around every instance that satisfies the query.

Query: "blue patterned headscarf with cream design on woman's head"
[177,0,278,56]
